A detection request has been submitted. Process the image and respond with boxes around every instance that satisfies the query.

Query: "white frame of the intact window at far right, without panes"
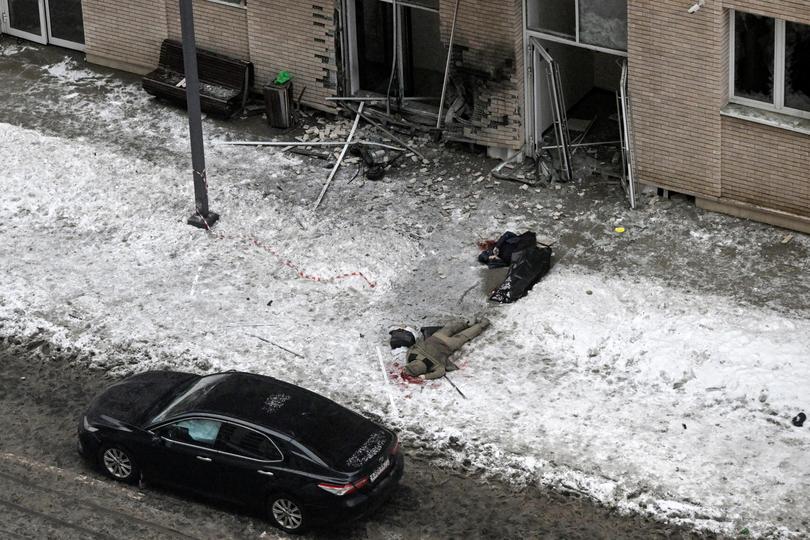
[728,9,810,119]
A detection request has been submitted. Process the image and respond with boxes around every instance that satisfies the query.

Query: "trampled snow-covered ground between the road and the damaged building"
[0,41,810,538]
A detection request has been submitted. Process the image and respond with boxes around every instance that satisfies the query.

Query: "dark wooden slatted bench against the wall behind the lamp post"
[142,39,254,117]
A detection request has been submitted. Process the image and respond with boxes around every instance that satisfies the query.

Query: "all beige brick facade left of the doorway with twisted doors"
[84,0,523,146]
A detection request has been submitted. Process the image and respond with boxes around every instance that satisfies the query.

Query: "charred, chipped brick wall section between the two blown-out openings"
[439,0,524,150]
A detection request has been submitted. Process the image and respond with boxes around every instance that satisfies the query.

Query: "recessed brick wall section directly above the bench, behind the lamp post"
[165,0,252,60]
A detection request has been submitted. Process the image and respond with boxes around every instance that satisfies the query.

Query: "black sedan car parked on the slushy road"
[79,371,404,533]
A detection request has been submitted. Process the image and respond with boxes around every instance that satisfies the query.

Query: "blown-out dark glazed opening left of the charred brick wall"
[344,0,445,106]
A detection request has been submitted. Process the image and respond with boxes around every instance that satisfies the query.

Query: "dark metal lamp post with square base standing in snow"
[180,0,219,229]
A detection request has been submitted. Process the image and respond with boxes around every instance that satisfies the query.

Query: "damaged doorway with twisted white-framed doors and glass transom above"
[525,0,636,206]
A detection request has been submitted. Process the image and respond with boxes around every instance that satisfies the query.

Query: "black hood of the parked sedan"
[87,371,199,425]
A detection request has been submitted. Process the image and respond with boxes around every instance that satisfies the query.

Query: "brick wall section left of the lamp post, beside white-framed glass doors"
[82,0,167,73]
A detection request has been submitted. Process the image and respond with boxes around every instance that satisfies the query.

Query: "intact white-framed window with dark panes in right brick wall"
[731,11,810,118]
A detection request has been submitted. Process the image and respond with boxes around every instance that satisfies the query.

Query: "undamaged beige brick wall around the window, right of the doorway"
[628,0,810,225]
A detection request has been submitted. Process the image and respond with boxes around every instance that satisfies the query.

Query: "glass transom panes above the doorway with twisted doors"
[526,0,627,52]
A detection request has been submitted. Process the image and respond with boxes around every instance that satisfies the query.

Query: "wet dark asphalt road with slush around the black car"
[0,340,696,539]
